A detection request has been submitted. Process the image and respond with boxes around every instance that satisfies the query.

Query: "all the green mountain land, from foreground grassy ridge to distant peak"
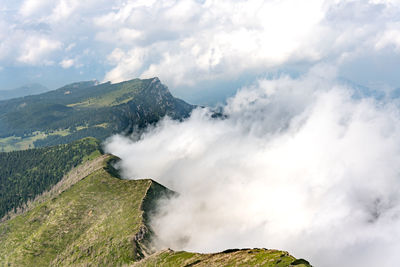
[0,78,310,267]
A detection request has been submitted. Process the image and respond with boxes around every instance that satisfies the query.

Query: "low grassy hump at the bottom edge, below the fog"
[132,249,311,267]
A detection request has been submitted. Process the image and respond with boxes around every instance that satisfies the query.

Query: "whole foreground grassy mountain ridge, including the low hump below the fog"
[0,155,310,267]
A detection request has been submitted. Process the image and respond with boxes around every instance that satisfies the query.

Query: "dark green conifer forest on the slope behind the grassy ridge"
[0,138,101,218]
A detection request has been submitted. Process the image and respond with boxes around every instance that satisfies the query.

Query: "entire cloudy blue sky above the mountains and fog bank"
[0,0,400,102]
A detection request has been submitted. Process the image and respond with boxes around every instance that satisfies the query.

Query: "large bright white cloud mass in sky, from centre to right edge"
[95,0,400,86]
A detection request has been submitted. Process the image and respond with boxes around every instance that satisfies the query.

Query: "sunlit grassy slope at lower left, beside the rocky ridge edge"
[0,155,166,266]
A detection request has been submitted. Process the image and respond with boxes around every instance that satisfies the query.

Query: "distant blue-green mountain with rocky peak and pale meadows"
[0,78,194,151]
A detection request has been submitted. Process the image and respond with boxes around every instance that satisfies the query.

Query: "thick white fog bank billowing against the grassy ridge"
[106,67,400,266]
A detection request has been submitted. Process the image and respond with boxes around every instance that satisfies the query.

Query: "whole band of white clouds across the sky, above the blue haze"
[0,0,400,91]
